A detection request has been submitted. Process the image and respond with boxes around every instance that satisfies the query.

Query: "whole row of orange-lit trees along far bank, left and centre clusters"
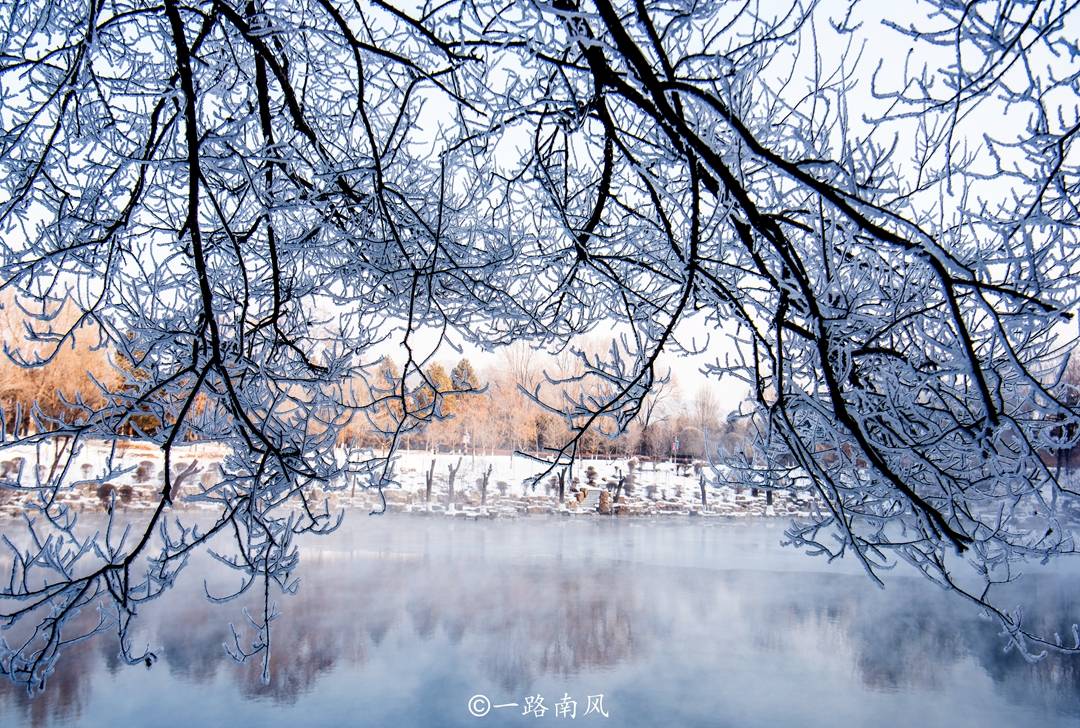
[0,298,750,459]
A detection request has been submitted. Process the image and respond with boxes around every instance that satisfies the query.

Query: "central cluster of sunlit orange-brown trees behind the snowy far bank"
[340,346,750,459]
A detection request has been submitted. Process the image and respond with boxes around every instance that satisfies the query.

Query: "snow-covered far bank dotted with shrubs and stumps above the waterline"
[0,442,812,517]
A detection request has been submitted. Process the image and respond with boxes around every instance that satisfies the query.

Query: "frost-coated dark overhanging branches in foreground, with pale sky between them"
[0,0,1080,688]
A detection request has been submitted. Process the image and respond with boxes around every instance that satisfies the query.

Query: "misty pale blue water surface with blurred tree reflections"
[0,515,1080,728]
